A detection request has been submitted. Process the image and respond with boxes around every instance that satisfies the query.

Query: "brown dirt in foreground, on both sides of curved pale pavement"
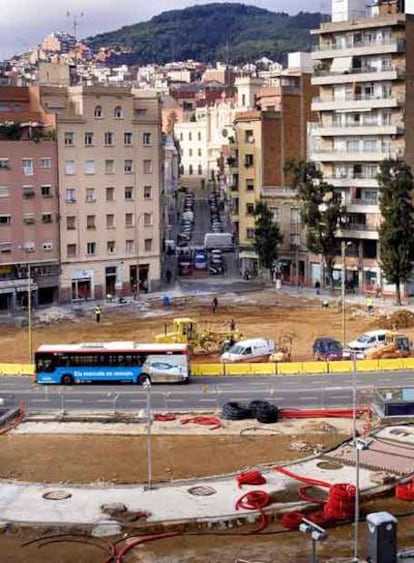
[0,433,414,563]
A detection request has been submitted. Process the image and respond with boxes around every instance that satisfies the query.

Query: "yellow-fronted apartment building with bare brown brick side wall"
[227,69,315,282]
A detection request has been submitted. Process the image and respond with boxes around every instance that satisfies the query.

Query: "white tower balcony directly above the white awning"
[312,38,405,60]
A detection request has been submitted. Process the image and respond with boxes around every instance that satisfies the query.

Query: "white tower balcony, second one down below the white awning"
[312,94,404,112]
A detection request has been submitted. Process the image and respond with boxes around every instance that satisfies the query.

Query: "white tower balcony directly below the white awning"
[312,67,405,86]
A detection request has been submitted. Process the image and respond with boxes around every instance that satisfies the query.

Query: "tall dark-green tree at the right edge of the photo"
[377,158,414,305]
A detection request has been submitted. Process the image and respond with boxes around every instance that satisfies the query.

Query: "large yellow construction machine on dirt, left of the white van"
[155,317,243,352]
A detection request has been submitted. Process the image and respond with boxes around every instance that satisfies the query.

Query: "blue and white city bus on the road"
[35,341,190,385]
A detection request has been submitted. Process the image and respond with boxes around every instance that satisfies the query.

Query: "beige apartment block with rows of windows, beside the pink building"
[41,86,163,301]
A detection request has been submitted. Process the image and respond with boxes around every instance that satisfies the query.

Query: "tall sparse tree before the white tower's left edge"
[286,161,345,286]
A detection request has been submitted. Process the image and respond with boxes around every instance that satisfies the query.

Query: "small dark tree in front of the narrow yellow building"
[254,201,283,272]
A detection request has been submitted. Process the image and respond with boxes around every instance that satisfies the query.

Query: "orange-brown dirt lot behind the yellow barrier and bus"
[0,291,402,362]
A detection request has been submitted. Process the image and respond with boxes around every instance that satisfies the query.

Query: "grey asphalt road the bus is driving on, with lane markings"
[0,372,414,411]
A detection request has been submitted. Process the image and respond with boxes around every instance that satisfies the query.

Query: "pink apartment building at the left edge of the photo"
[0,86,60,314]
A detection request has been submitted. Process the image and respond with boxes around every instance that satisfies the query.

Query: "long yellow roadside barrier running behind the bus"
[0,358,414,377]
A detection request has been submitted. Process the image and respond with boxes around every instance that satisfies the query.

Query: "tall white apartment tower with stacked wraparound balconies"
[310,0,414,289]
